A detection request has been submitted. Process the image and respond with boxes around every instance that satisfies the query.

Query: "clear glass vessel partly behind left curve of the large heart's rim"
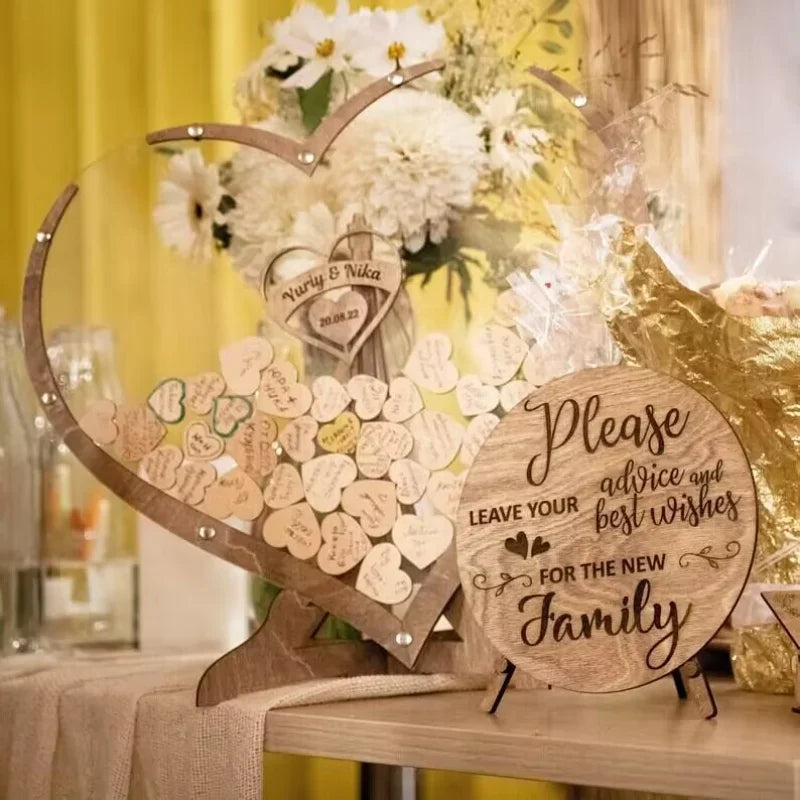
[43,326,138,648]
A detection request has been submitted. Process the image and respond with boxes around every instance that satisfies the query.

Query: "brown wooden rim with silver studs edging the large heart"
[22,61,459,680]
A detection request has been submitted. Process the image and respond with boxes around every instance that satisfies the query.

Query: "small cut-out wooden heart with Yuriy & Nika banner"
[261,229,403,365]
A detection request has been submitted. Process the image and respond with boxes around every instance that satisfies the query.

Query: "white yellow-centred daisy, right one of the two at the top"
[353,8,444,76]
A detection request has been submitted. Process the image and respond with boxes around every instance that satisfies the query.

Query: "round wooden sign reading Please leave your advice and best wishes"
[457,367,757,692]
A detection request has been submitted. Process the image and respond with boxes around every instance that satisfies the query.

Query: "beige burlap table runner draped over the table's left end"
[0,654,486,800]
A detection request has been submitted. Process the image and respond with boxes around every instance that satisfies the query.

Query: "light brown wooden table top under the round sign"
[264,679,800,800]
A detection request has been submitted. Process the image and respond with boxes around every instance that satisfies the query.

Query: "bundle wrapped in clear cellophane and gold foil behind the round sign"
[510,76,800,693]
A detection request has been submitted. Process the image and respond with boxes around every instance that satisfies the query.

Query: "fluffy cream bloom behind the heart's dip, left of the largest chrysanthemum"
[226,117,328,286]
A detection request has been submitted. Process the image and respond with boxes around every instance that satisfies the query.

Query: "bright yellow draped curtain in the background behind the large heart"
[0,0,579,800]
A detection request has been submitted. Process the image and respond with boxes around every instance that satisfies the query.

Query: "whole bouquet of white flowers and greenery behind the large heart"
[155,0,574,320]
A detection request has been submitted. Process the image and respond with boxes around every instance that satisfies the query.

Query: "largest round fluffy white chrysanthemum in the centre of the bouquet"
[331,89,484,253]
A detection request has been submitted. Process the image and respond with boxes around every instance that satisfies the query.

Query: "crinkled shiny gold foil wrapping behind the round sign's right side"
[610,228,800,692]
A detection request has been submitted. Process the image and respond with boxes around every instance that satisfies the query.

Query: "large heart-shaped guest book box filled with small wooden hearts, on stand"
[24,62,528,704]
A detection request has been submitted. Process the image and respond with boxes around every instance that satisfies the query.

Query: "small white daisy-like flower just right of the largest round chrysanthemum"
[475,89,550,180]
